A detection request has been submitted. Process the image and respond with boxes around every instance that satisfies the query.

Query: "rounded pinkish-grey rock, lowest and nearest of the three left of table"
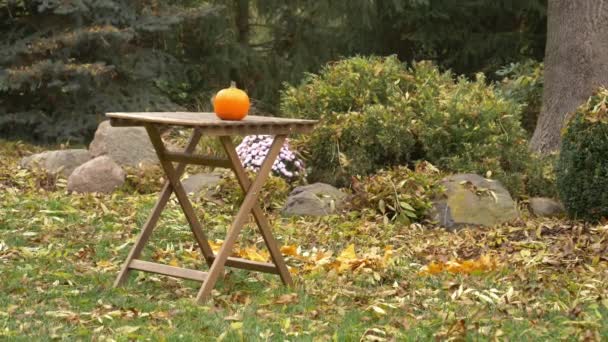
[68,156,126,193]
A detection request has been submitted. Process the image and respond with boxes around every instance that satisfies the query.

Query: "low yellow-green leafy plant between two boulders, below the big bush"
[351,163,443,224]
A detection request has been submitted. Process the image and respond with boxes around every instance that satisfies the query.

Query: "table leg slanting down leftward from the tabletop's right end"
[196,135,286,303]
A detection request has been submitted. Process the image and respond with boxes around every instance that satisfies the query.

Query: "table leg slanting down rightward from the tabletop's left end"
[146,124,214,266]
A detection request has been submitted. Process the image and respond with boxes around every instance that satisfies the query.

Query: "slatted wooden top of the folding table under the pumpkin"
[106,112,317,135]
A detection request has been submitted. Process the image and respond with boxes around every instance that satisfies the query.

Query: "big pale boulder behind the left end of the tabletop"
[89,121,158,167]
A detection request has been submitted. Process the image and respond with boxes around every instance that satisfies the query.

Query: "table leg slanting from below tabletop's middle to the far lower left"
[114,129,202,287]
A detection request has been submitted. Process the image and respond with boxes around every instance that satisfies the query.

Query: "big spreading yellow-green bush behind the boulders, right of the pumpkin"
[281,57,530,196]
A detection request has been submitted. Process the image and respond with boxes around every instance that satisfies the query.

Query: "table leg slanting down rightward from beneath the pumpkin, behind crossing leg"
[220,136,293,286]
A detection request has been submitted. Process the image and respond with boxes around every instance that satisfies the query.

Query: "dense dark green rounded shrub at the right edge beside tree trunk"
[556,88,608,221]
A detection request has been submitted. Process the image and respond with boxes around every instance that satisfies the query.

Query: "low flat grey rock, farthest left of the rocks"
[21,149,91,178]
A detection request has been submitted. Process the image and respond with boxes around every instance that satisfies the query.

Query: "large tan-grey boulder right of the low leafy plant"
[431,174,519,229]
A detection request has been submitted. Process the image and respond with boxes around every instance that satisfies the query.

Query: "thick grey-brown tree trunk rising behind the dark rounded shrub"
[530,0,608,153]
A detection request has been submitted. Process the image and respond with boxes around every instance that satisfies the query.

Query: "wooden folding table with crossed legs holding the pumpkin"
[106,112,316,303]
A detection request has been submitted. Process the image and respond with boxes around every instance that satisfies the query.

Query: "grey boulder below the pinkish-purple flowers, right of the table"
[282,183,346,216]
